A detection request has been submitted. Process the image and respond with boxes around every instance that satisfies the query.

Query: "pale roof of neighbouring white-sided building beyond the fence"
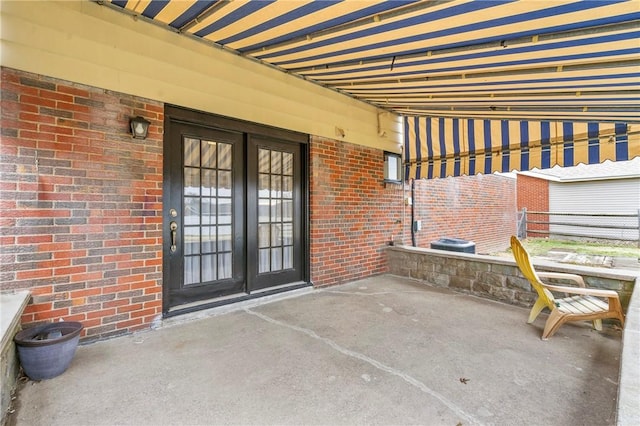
[519,157,640,182]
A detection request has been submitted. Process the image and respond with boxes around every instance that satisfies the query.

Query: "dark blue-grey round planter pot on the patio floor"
[14,322,82,380]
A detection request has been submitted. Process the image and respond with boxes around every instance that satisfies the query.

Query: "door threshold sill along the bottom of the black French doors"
[163,281,312,318]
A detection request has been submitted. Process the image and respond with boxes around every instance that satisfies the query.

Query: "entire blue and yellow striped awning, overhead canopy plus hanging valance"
[100,0,640,177]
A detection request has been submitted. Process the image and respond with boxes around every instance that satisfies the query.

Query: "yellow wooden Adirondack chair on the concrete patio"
[511,236,624,340]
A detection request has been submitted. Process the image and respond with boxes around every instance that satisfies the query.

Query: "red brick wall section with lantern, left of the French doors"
[0,68,163,340]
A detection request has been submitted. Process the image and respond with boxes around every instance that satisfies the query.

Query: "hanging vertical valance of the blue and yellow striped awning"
[404,117,640,179]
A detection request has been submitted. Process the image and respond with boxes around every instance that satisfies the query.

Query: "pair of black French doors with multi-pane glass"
[163,109,308,313]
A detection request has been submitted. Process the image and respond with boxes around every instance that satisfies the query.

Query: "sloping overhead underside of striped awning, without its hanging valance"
[104,0,640,122]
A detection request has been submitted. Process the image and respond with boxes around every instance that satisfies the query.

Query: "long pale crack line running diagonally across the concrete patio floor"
[244,308,482,424]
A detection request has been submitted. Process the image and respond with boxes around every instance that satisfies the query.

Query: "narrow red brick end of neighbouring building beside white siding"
[517,174,549,237]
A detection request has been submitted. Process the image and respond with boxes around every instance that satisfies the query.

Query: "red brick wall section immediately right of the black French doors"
[310,137,402,286]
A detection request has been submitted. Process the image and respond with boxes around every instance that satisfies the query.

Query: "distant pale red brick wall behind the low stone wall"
[405,175,517,253]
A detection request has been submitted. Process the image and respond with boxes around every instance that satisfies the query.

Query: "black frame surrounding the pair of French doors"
[162,105,311,317]
